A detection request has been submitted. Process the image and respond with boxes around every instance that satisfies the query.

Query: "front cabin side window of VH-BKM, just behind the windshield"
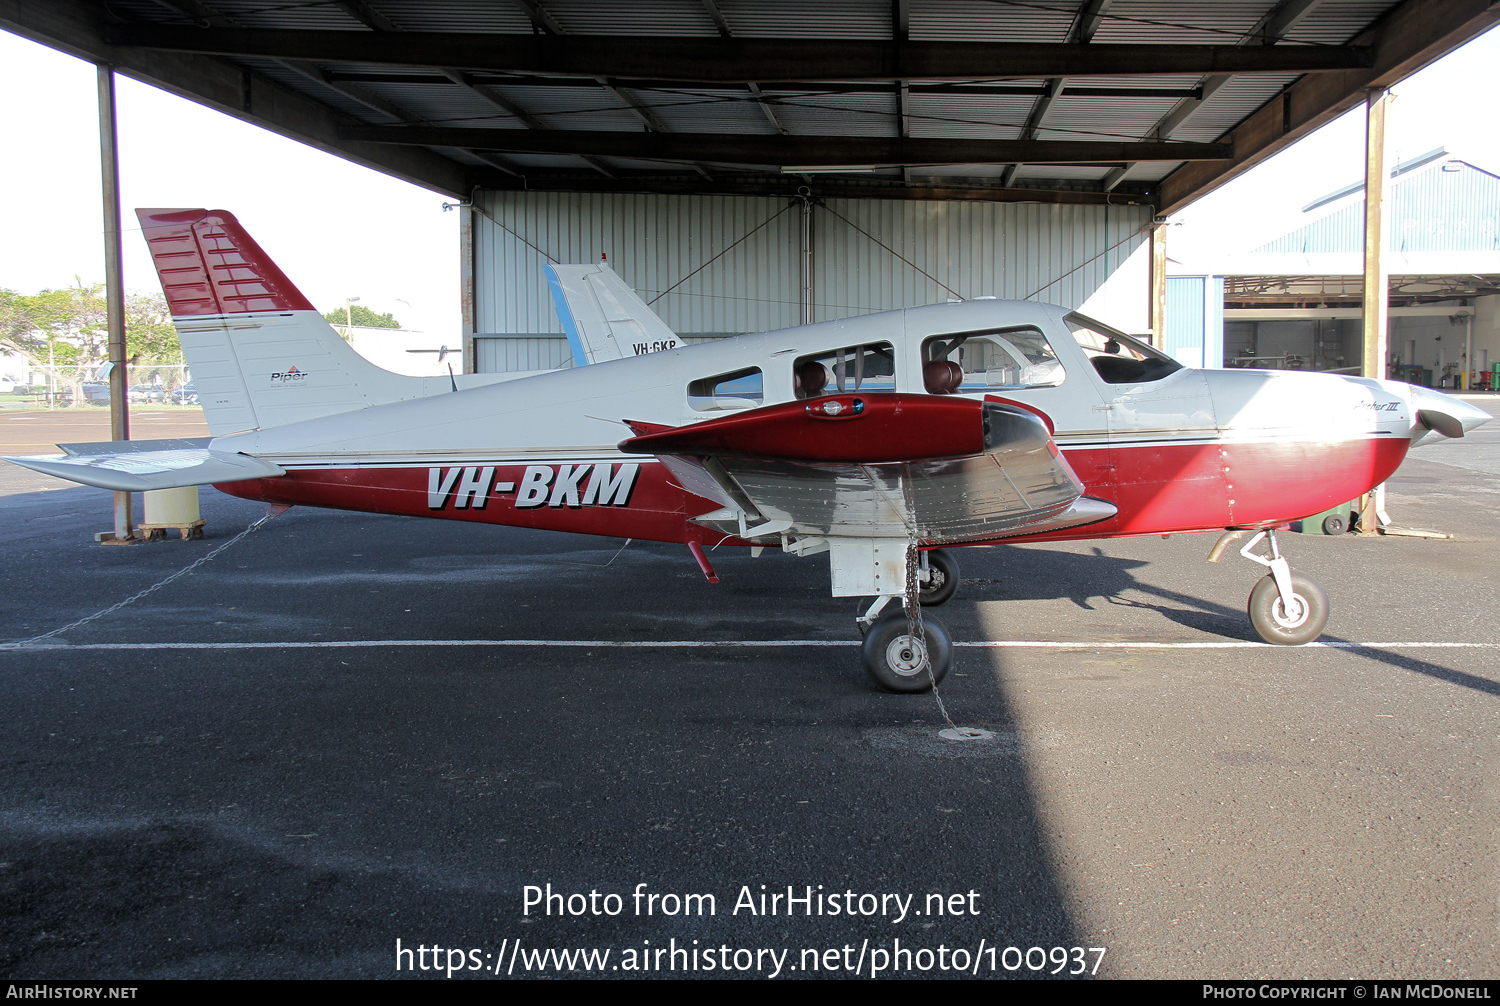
[923,327,1067,394]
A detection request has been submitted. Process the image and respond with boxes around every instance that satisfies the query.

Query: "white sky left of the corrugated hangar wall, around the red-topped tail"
[0,31,461,342]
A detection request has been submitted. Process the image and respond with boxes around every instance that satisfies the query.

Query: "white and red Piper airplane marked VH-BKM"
[8,210,1490,691]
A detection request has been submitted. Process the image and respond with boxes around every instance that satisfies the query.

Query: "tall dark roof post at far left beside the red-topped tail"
[98,63,134,541]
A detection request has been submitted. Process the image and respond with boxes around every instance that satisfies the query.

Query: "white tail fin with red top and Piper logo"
[135,210,452,436]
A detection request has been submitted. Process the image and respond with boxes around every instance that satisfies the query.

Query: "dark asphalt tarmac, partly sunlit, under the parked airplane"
[0,406,1500,981]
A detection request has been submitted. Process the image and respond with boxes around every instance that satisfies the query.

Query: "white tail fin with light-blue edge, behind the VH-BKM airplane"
[542,261,683,366]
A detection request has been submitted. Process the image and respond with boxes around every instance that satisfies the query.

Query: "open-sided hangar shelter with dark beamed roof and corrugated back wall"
[0,0,1500,377]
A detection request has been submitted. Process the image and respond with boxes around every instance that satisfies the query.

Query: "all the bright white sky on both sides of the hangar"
[0,19,1500,340]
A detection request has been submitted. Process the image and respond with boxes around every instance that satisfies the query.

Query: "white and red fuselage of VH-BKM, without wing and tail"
[216,300,1425,544]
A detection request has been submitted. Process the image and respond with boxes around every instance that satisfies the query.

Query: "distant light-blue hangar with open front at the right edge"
[1163,147,1500,390]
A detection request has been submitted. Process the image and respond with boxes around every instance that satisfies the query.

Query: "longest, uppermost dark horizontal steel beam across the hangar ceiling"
[108,24,1373,84]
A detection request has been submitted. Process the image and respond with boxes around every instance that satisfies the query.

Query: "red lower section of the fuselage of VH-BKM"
[218,438,1410,544]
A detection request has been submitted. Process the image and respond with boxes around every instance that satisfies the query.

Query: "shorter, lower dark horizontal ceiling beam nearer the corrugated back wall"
[342,126,1233,168]
